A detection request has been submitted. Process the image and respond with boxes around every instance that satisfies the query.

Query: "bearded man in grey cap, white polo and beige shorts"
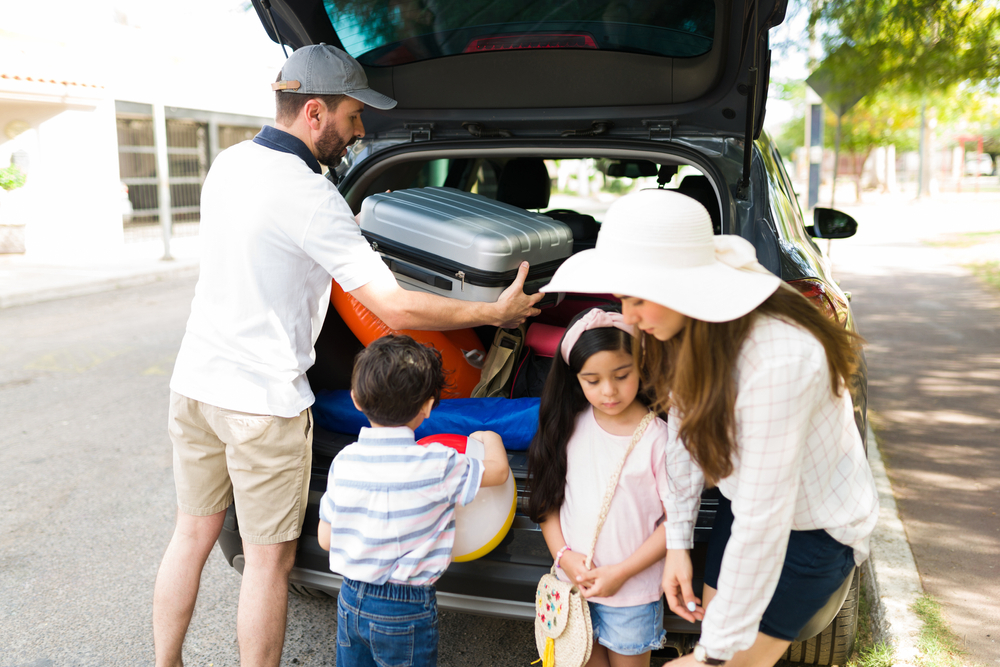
[153,44,541,667]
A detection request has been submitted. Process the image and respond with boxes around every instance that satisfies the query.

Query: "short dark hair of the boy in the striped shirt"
[351,335,446,426]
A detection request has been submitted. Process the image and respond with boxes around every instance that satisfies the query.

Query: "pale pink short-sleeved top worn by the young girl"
[557,405,667,607]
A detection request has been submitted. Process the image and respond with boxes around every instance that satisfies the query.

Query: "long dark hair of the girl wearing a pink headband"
[528,306,632,523]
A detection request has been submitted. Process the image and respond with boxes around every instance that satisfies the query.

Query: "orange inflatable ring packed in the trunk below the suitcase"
[330,280,486,398]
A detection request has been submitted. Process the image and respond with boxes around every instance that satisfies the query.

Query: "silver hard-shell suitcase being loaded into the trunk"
[360,187,573,306]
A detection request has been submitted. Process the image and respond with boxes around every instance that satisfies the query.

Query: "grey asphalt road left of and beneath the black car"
[0,278,537,667]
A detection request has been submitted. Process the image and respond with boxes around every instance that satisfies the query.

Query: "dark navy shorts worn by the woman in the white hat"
[705,496,854,641]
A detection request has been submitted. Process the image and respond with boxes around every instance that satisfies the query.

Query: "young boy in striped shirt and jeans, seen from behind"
[318,336,510,667]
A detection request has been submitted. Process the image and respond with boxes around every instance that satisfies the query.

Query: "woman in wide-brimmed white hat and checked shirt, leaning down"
[542,190,878,667]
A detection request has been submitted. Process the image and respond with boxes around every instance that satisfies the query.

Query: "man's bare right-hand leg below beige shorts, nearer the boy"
[236,540,296,667]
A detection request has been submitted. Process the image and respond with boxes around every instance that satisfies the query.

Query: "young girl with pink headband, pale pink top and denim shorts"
[528,308,667,667]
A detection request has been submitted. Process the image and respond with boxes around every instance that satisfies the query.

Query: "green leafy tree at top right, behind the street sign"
[797,0,1000,193]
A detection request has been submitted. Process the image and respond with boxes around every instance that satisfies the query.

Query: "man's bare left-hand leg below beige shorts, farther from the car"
[153,510,226,667]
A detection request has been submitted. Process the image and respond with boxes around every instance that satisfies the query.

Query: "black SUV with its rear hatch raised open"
[219,0,867,665]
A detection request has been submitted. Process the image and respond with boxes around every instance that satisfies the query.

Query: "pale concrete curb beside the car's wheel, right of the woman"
[862,426,924,667]
